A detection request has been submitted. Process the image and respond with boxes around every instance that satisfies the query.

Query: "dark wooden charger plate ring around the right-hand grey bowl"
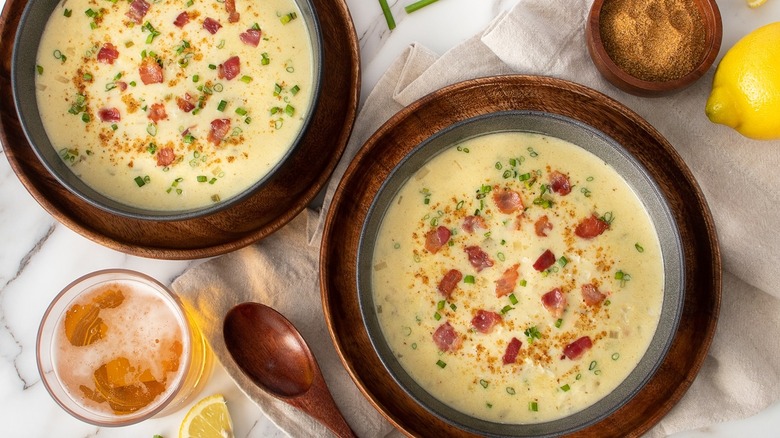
[320,75,721,437]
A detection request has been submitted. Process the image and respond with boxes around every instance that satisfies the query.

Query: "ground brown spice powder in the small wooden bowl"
[599,0,705,82]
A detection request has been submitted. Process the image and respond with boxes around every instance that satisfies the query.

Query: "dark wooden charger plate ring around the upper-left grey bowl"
[0,0,360,259]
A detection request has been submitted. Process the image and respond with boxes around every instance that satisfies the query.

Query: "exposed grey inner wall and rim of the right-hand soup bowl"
[357,111,685,436]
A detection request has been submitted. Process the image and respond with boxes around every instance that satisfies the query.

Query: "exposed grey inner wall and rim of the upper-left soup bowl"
[11,0,323,221]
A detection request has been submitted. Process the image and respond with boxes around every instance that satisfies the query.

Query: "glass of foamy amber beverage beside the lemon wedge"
[37,269,211,426]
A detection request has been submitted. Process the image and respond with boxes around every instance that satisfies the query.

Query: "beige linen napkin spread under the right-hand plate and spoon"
[173,0,780,437]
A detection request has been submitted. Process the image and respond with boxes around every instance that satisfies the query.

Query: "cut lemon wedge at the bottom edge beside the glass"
[179,394,233,438]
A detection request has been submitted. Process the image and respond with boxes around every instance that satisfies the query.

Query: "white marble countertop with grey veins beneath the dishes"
[0,0,780,438]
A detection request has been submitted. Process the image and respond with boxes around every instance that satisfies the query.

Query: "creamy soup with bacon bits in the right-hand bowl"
[371,132,664,424]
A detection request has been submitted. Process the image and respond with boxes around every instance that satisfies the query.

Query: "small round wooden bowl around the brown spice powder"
[585,0,723,97]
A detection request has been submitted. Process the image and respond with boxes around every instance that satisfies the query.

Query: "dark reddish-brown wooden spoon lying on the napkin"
[223,303,356,437]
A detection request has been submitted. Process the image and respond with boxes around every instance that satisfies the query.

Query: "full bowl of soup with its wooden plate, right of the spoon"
[321,76,719,436]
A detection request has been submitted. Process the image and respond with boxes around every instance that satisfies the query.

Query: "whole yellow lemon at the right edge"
[705,22,780,140]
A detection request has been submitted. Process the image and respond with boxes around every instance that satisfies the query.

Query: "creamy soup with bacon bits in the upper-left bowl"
[36,0,314,211]
